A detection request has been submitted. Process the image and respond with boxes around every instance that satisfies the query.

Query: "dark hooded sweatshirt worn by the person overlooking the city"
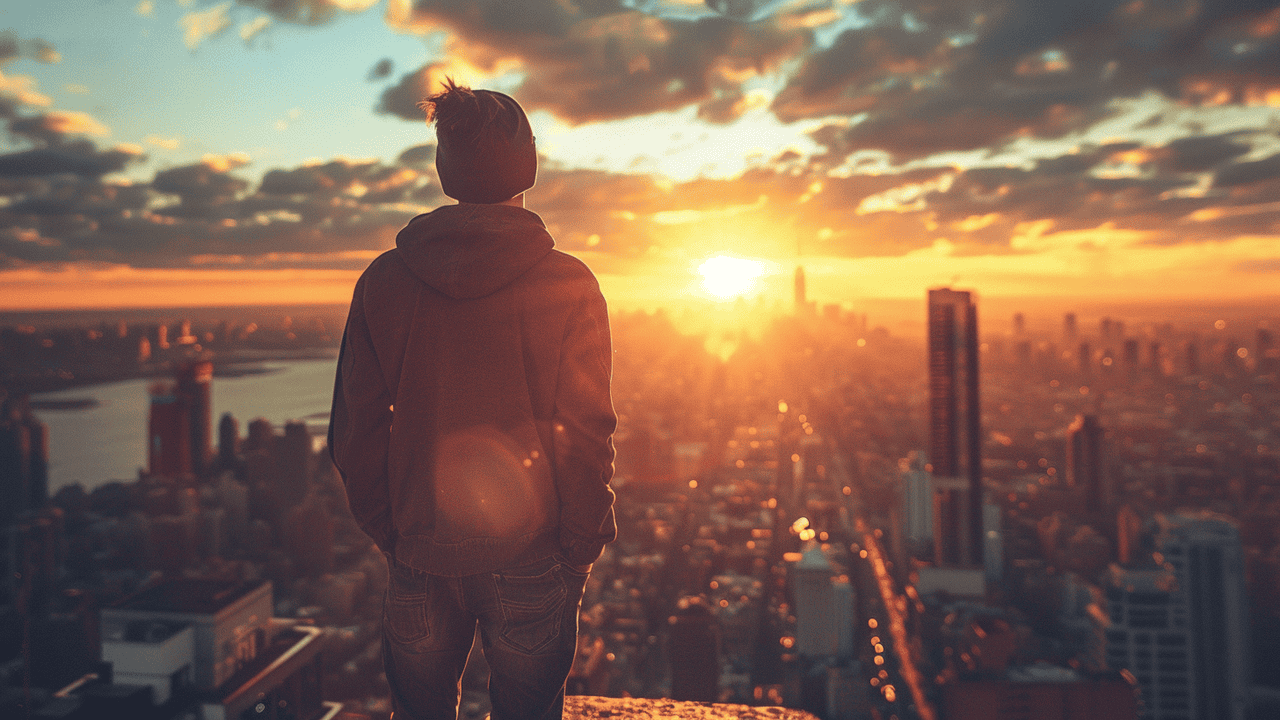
[329,204,617,577]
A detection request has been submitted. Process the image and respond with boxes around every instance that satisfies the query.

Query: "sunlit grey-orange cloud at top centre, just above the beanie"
[380,0,808,123]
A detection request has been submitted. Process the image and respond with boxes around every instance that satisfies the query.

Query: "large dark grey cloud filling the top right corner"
[772,0,1280,160]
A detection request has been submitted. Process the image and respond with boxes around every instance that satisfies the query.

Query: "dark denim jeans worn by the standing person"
[383,556,590,720]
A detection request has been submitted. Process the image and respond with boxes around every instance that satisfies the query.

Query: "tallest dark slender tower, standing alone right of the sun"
[929,288,983,566]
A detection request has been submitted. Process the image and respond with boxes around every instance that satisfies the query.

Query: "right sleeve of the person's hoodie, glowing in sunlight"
[553,283,618,565]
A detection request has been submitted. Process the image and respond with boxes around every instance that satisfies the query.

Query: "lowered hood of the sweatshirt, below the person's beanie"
[396,204,556,300]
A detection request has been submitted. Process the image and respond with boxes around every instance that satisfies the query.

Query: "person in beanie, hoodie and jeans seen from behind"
[329,79,617,720]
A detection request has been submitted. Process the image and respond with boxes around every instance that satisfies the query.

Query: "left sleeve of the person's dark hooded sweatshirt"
[329,278,394,552]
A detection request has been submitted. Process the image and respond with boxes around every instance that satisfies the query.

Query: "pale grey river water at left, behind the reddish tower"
[32,359,335,493]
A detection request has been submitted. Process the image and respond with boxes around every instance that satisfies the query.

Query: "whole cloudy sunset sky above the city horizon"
[0,0,1280,309]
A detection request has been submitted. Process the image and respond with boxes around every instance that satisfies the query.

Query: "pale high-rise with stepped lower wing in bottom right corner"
[1106,512,1249,720]
